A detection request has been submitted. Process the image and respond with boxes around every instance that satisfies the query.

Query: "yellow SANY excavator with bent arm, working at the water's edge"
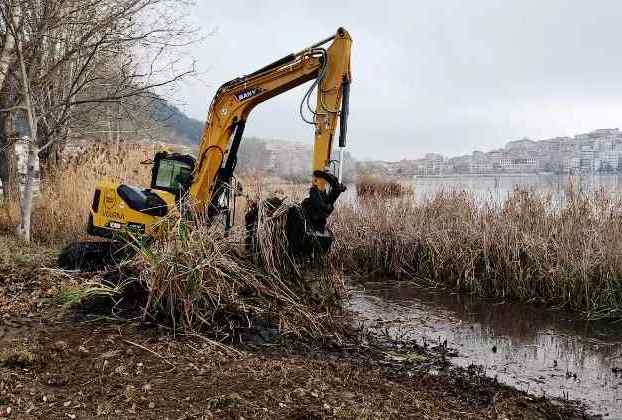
[60,28,352,266]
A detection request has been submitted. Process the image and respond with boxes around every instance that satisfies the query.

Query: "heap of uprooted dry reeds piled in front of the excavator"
[119,202,344,341]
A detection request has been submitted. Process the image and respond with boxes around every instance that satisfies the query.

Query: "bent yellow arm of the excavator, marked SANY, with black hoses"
[189,28,352,230]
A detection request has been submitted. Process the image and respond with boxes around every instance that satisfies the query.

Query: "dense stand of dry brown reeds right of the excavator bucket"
[333,190,622,317]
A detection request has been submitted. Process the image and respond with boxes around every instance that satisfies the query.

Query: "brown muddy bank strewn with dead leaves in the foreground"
[0,237,588,419]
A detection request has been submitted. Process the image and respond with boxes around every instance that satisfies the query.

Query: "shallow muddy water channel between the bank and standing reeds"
[351,281,622,419]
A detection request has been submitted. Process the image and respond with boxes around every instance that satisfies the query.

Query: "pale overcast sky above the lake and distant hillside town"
[178,0,622,160]
